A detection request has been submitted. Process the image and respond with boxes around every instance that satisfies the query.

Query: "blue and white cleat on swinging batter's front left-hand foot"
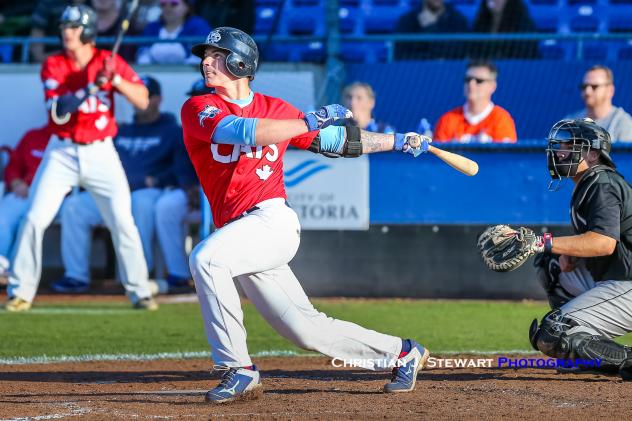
[204,365,263,403]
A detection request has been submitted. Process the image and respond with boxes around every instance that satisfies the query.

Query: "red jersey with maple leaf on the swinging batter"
[181,94,318,227]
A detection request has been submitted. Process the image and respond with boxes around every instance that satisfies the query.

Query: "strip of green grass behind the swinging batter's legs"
[0,299,632,359]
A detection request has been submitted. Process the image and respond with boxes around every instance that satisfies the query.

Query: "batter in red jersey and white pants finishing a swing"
[181,27,431,403]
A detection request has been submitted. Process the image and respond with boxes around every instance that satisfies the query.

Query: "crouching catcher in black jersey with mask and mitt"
[478,119,632,380]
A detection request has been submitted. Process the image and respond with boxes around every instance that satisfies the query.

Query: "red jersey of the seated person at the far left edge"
[4,126,51,188]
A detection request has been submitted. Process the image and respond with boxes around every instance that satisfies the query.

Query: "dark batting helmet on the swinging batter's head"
[191,26,259,79]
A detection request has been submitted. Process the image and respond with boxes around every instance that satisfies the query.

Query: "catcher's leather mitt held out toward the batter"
[478,225,552,272]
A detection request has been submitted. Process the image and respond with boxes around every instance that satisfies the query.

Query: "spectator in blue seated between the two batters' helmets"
[137,0,211,64]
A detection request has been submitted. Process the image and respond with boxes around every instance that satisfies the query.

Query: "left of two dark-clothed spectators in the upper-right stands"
[395,0,468,60]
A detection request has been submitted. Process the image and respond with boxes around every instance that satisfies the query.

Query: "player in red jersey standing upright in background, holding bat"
[6,5,157,311]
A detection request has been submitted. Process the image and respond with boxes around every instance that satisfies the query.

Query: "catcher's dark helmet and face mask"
[546,118,615,190]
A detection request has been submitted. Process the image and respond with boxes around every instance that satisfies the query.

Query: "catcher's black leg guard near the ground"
[529,309,632,371]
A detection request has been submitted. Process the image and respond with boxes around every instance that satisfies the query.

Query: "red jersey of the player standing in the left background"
[41,48,142,143]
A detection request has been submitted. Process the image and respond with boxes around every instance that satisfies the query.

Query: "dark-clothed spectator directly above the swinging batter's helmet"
[195,0,255,34]
